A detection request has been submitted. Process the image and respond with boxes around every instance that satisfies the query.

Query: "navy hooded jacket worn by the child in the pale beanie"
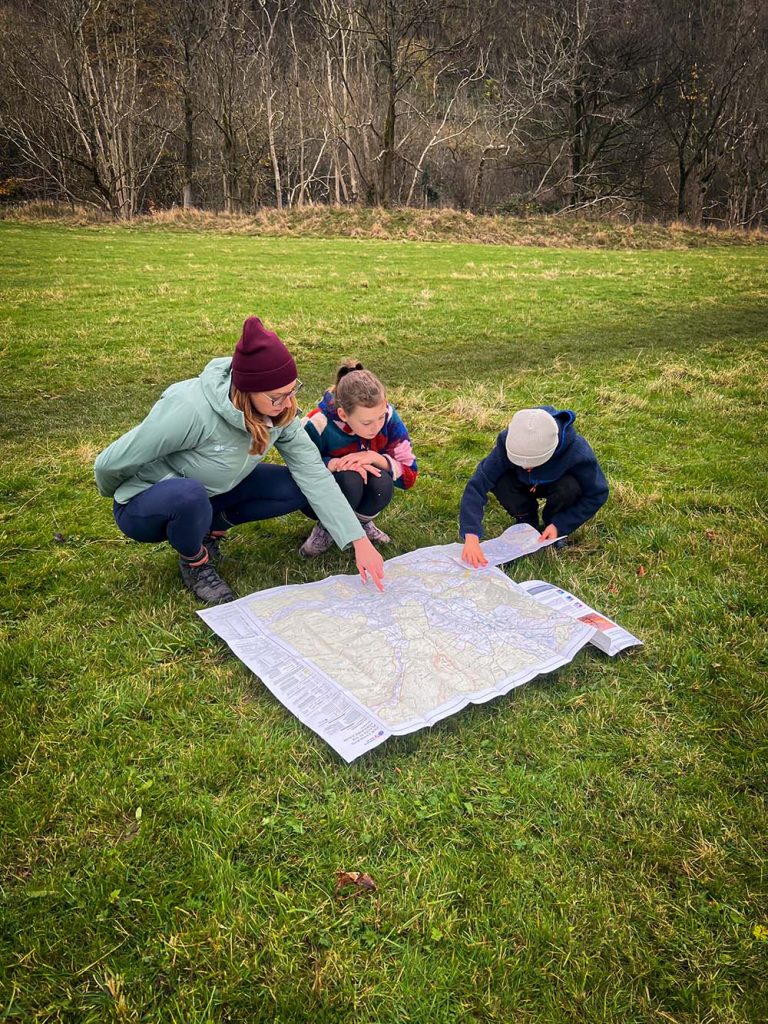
[459,406,608,540]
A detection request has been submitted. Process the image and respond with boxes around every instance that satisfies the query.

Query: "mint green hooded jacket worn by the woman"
[93,357,365,548]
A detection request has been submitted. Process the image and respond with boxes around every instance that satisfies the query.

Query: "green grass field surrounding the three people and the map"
[0,223,768,1024]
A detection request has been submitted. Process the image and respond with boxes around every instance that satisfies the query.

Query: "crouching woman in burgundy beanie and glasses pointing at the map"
[94,316,384,604]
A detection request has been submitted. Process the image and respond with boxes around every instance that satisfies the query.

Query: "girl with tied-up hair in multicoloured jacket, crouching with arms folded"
[299,359,417,558]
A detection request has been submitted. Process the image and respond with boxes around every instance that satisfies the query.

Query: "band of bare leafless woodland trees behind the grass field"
[0,0,768,227]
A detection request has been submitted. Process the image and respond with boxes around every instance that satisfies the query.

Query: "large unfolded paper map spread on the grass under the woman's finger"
[199,545,595,761]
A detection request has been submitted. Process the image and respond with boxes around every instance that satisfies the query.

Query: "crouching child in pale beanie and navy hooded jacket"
[459,406,608,568]
